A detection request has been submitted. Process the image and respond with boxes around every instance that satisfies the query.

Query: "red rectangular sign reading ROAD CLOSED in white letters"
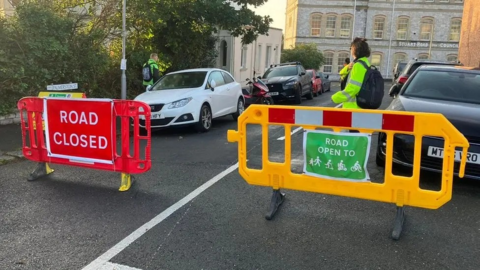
[44,98,115,164]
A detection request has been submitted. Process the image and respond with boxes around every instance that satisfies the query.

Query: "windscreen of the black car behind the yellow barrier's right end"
[402,70,480,104]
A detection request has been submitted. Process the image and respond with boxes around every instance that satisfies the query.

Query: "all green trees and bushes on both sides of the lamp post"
[0,0,272,115]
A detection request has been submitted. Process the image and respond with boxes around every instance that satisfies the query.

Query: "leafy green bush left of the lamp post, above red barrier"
[0,4,108,114]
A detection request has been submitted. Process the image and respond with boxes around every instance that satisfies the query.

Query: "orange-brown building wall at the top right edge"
[458,0,480,67]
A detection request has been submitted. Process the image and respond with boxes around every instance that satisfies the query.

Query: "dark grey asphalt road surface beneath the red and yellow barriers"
[0,83,480,270]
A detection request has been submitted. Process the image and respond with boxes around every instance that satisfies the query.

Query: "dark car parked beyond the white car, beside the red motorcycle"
[262,62,313,104]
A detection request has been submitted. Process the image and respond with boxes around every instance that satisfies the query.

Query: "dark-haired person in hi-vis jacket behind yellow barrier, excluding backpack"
[332,37,370,109]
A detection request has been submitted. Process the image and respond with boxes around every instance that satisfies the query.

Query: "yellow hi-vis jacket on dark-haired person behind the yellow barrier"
[332,57,370,109]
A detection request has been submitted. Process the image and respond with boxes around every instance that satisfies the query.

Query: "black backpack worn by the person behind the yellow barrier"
[357,60,385,109]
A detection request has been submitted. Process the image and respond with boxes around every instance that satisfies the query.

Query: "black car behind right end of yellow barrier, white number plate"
[376,65,480,180]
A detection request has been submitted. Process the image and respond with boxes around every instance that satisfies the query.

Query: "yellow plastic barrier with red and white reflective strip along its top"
[228,105,469,239]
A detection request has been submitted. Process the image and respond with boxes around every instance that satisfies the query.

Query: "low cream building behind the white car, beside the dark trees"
[216,28,283,85]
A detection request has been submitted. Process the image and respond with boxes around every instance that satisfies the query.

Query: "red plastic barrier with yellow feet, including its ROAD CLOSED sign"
[17,97,151,191]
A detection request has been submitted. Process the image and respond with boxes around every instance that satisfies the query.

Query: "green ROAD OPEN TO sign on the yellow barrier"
[303,130,371,182]
